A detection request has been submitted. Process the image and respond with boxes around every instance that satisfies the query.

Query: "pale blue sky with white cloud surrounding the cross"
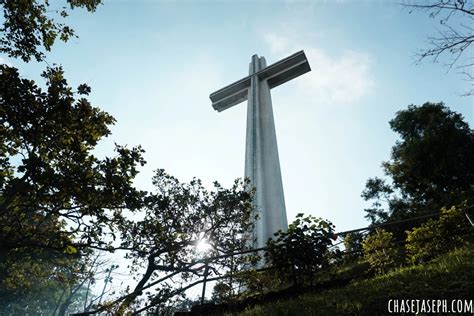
[3,0,474,230]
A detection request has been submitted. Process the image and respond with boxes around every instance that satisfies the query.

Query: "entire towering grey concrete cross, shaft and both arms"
[209,51,311,248]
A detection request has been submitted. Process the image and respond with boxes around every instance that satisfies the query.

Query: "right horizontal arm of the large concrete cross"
[257,50,311,88]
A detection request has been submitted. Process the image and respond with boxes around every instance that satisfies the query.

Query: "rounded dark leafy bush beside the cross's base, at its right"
[265,213,334,285]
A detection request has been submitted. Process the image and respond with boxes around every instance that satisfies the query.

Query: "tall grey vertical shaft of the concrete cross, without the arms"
[245,55,288,248]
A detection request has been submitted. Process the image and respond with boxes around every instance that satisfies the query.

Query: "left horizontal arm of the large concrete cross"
[209,76,250,112]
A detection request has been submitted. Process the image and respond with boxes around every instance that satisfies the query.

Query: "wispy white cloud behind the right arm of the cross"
[263,33,375,104]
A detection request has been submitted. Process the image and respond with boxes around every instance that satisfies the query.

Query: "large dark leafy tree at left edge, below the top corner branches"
[0,65,144,313]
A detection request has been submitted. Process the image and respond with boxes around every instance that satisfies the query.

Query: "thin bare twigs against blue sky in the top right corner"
[404,0,474,95]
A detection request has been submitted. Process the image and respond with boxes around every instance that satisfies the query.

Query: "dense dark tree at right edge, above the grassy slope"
[362,103,474,223]
